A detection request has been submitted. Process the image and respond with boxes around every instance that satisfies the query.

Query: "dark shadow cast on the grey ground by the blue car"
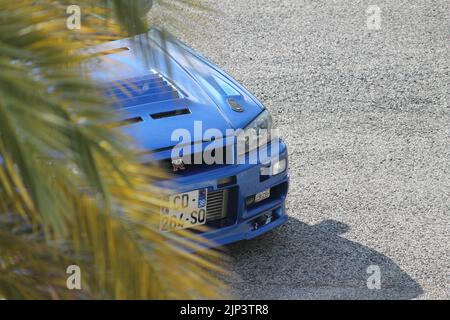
[226,218,423,299]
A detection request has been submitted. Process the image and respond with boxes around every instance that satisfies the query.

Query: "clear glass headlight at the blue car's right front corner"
[237,110,272,156]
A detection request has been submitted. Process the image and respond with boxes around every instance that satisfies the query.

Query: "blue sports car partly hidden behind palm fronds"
[91,29,289,245]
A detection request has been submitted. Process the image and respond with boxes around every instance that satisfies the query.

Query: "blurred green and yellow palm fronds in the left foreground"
[0,0,226,299]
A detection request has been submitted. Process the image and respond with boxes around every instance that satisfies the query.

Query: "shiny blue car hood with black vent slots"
[86,29,263,151]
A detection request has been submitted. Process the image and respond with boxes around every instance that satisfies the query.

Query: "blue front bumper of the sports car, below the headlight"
[156,141,289,247]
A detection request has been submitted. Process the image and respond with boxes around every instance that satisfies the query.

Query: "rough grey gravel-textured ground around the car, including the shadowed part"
[171,0,450,299]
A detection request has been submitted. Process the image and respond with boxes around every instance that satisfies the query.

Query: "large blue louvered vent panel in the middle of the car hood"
[106,74,180,108]
